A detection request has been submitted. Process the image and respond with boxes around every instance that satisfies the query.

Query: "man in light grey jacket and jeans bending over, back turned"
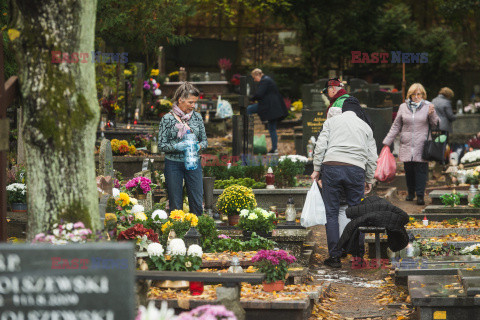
[311,106,377,268]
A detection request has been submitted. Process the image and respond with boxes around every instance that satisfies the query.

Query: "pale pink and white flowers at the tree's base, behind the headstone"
[33,221,92,245]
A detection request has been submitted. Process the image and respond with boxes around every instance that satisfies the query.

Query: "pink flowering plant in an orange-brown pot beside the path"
[252,250,296,292]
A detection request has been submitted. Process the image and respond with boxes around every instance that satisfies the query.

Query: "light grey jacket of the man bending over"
[313,111,377,183]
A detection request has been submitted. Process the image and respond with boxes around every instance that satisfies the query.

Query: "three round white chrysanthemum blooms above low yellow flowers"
[147,238,203,271]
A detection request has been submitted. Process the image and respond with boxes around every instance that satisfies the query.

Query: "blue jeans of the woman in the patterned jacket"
[165,159,203,216]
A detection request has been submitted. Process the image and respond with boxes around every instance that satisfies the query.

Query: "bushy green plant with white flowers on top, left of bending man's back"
[273,155,308,188]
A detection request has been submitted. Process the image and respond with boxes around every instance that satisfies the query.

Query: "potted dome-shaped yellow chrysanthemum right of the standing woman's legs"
[217,184,257,226]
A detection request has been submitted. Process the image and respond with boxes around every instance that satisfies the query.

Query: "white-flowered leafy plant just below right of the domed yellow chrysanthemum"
[238,208,277,233]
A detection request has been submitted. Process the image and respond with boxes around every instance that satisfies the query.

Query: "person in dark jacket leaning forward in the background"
[247,68,288,154]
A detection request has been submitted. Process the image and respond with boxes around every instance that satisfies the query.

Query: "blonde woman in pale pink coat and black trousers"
[383,83,439,205]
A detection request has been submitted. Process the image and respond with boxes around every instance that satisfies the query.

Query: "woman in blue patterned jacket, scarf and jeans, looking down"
[158,82,207,215]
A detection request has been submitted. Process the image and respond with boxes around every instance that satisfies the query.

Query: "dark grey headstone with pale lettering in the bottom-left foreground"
[0,243,135,320]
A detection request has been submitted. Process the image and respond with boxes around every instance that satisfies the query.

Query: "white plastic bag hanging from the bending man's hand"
[300,181,327,227]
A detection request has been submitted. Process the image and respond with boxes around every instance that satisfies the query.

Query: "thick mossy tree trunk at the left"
[13,0,100,240]
